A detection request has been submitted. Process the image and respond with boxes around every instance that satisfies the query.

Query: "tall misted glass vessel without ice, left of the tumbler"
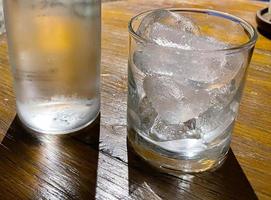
[4,0,101,134]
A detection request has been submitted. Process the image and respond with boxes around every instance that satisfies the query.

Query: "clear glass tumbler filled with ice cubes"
[127,8,257,173]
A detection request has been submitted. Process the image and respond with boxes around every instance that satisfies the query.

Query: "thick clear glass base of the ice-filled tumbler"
[128,130,230,173]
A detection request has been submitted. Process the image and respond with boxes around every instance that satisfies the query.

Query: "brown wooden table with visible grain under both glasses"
[0,0,271,200]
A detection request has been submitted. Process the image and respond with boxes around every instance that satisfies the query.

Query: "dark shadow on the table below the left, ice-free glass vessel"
[0,116,100,199]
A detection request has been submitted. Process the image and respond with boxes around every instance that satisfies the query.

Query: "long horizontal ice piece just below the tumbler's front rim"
[133,37,232,84]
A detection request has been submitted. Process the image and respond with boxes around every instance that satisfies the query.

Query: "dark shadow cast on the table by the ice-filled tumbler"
[127,144,257,200]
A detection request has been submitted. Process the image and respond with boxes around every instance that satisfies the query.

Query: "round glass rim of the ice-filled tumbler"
[128,8,258,52]
